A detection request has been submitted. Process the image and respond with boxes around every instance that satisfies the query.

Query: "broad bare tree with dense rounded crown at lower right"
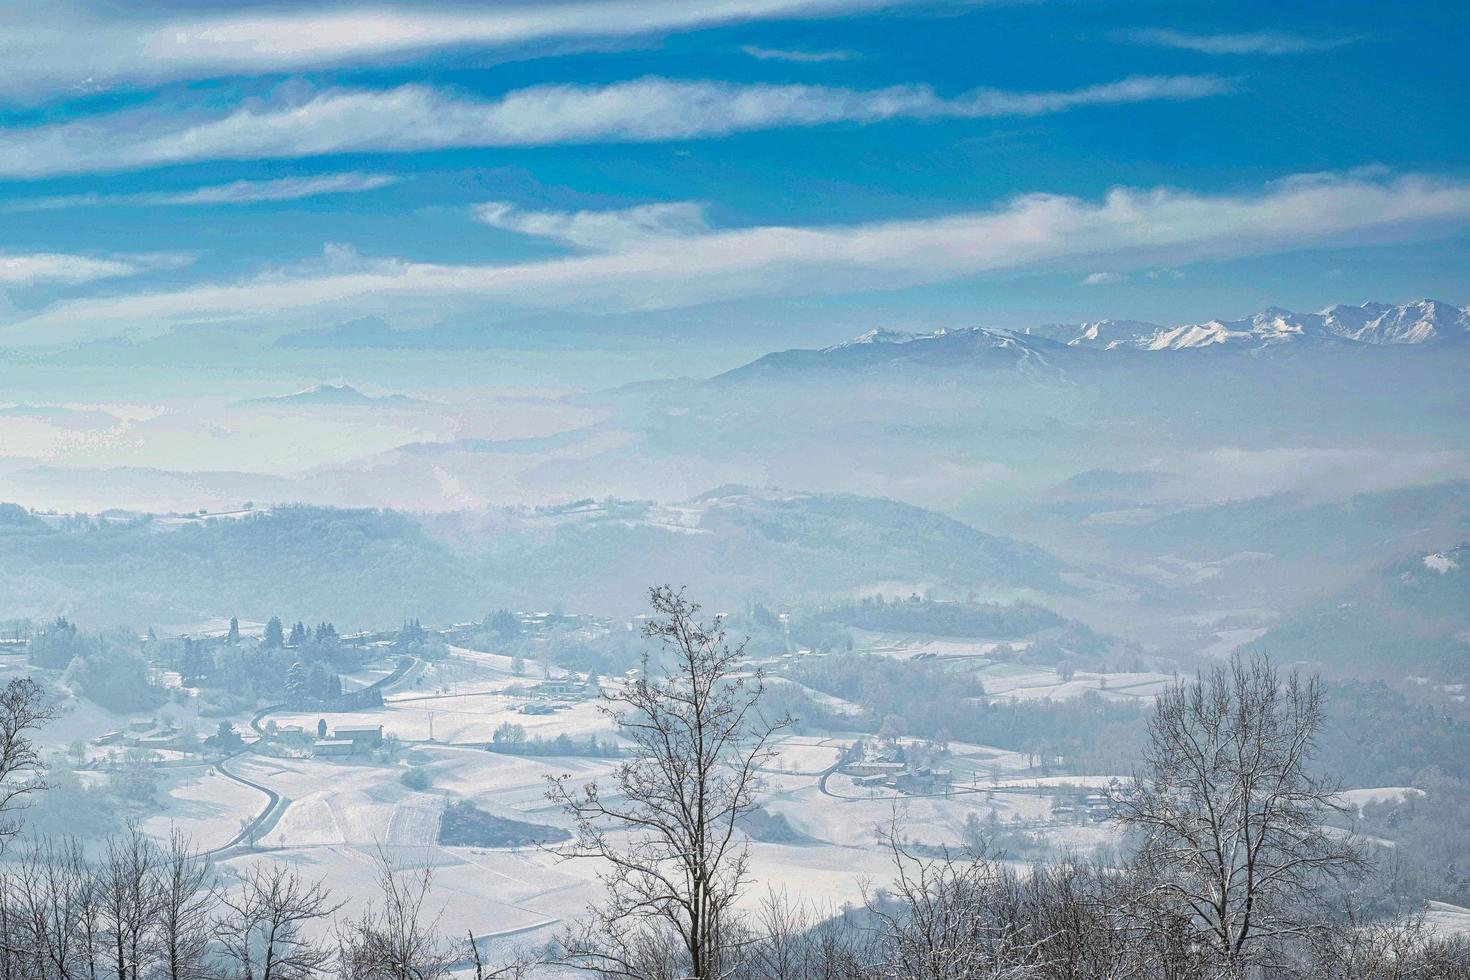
[1113,655,1363,976]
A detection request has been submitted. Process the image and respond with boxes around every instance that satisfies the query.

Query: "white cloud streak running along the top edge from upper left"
[0,0,913,97]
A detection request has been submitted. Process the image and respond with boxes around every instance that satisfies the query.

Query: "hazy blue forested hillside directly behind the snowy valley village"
[0,489,1063,627]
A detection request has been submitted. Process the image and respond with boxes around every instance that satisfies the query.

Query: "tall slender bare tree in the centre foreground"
[548,586,789,980]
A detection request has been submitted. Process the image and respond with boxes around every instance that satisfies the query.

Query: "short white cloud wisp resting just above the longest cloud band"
[475,201,709,251]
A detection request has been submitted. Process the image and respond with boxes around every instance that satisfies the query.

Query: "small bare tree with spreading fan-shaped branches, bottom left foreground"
[216,864,341,980]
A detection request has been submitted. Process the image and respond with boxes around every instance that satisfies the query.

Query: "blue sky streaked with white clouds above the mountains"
[0,0,1470,401]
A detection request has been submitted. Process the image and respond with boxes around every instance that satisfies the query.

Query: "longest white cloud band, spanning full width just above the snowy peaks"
[0,175,1470,345]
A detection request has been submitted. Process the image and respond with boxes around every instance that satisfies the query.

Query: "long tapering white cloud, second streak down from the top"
[0,75,1229,178]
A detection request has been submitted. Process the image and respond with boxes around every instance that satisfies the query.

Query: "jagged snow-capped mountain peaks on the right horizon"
[1023,300,1470,351]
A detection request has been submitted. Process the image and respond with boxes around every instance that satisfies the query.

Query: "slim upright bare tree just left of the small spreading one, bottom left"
[153,830,219,980]
